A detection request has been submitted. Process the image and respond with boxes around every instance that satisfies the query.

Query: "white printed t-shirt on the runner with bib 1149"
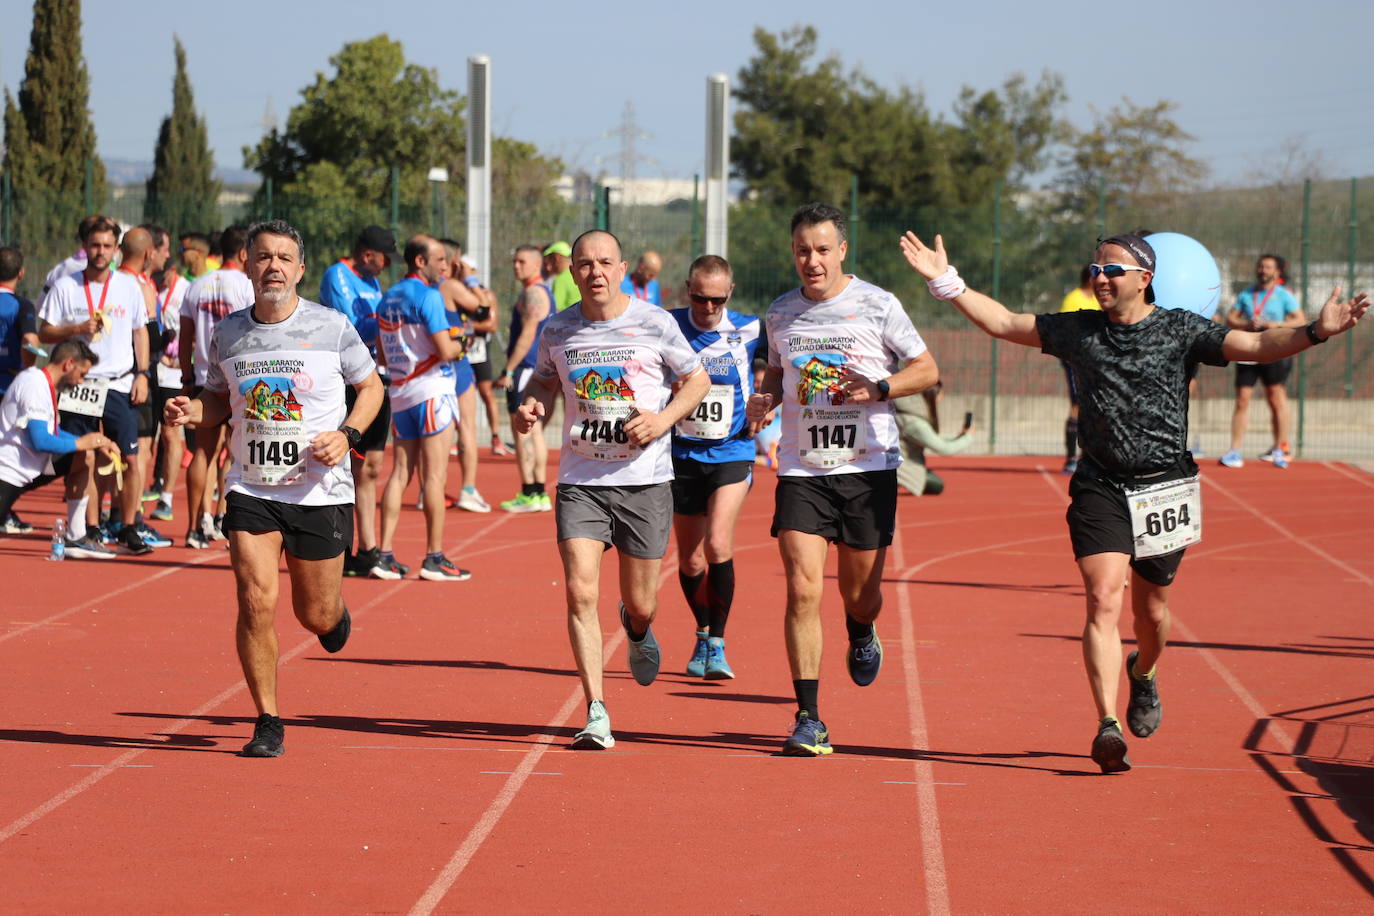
[205,299,375,505]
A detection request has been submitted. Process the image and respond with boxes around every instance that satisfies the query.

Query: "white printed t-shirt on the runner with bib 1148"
[534,299,701,486]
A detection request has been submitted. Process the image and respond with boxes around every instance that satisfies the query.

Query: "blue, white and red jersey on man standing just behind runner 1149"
[376,273,453,411]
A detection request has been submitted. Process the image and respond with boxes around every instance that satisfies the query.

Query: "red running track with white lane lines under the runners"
[0,457,1374,913]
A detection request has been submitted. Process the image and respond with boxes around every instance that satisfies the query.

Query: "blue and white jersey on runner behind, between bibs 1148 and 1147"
[668,309,768,464]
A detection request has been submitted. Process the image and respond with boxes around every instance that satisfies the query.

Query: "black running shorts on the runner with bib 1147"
[772,470,897,551]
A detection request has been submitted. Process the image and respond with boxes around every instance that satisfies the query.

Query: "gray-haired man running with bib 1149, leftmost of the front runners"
[164,220,382,757]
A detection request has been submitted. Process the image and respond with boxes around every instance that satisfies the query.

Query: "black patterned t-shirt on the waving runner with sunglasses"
[1035,308,1227,475]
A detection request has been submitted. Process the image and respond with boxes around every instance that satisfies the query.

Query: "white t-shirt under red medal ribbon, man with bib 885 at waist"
[38,271,148,394]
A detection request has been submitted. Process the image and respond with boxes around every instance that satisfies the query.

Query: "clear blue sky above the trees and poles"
[0,0,1374,181]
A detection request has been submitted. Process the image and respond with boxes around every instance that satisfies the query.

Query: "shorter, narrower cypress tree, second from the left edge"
[143,38,220,233]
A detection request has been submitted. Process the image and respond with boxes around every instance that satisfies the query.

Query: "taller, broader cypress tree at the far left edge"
[4,0,104,255]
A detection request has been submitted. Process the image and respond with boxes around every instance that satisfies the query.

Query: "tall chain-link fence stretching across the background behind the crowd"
[0,170,1374,460]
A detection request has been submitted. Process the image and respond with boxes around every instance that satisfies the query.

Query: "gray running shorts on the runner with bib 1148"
[555,481,673,560]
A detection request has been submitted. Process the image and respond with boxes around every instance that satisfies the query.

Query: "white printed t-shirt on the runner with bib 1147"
[765,276,926,477]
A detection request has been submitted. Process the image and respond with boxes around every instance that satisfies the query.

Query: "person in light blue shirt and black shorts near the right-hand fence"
[1220,254,1307,468]
